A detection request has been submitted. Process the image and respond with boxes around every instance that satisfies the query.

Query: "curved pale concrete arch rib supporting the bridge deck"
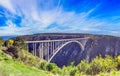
[48,40,84,62]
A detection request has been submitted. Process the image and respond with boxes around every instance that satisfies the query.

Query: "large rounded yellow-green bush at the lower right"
[90,56,117,74]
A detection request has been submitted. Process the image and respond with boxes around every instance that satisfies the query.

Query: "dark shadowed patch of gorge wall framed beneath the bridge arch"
[51,42,85,67]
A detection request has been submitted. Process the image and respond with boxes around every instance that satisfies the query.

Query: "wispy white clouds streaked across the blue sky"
[0,0,120,36]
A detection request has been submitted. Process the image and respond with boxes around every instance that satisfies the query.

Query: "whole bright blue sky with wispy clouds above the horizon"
[0,0,120,36]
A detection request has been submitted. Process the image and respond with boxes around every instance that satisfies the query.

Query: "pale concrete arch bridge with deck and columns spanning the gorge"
[26,37,89,62]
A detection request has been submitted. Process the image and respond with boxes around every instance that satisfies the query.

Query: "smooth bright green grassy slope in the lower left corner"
[0,51,50,76]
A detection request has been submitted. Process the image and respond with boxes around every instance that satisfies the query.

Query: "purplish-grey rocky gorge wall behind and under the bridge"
[22,34,120,67]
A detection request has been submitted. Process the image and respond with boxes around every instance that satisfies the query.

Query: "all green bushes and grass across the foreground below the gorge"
[0,37,120,76]
